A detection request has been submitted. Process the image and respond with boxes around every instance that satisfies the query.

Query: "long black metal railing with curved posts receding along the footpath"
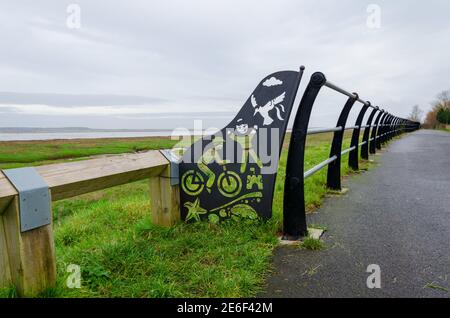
[283,72,420,240]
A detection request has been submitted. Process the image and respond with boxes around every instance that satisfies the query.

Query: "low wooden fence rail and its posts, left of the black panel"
[0,150,180,296]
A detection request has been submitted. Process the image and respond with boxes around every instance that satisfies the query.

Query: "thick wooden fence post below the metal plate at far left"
[0,196,56,297]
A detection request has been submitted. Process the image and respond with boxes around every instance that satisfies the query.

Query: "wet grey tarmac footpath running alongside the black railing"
[260,130,450,297]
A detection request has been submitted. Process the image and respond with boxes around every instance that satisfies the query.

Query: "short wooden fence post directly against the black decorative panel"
[150,165,180,226]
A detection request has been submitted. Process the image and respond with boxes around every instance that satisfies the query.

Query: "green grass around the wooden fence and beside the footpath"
[0,134,372,297]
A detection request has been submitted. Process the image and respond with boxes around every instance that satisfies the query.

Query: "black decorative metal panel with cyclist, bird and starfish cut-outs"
[179,67,304,222]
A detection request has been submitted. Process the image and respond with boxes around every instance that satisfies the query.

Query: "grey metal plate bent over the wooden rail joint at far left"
[3,168,51,232]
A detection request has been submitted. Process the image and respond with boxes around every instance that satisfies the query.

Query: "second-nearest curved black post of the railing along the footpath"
[327,93,359,191]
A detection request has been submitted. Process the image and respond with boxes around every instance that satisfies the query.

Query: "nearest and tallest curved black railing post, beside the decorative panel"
[283,72,326,240]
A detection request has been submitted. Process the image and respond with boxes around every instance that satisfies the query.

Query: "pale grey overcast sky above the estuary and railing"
[0,0,450,128]
